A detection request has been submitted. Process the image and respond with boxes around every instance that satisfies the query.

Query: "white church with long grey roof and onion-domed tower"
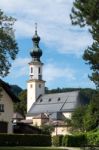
[26,26,86,134]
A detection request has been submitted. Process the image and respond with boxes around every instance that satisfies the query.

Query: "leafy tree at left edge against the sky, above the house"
[0,9,18,77]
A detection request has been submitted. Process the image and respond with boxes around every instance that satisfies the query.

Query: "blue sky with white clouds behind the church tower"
[0,0,95,89]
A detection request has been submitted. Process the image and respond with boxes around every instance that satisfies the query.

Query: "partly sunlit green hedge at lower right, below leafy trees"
[52,131,99,147]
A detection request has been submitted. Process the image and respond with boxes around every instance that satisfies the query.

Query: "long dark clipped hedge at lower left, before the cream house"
[0,134,51,146]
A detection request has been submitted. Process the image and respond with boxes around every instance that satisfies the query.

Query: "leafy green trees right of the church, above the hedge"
[71,91,99,131]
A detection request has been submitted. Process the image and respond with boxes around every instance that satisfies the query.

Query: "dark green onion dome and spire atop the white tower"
[30,23,42,61]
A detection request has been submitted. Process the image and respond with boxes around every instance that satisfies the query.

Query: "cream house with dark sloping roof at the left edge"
[0,79,19,133]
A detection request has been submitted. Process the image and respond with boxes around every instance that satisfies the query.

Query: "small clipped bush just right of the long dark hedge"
[52,135,63,146]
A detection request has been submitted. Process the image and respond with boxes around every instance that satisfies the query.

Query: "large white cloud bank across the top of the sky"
[0,0,92,55]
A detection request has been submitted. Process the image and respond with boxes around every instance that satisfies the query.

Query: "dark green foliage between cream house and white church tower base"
[15,90,27,117]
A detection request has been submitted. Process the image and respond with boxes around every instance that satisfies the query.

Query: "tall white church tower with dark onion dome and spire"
[27,24,45,112]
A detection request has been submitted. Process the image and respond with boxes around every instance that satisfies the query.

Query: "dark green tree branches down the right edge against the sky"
[70,0,99,88]
